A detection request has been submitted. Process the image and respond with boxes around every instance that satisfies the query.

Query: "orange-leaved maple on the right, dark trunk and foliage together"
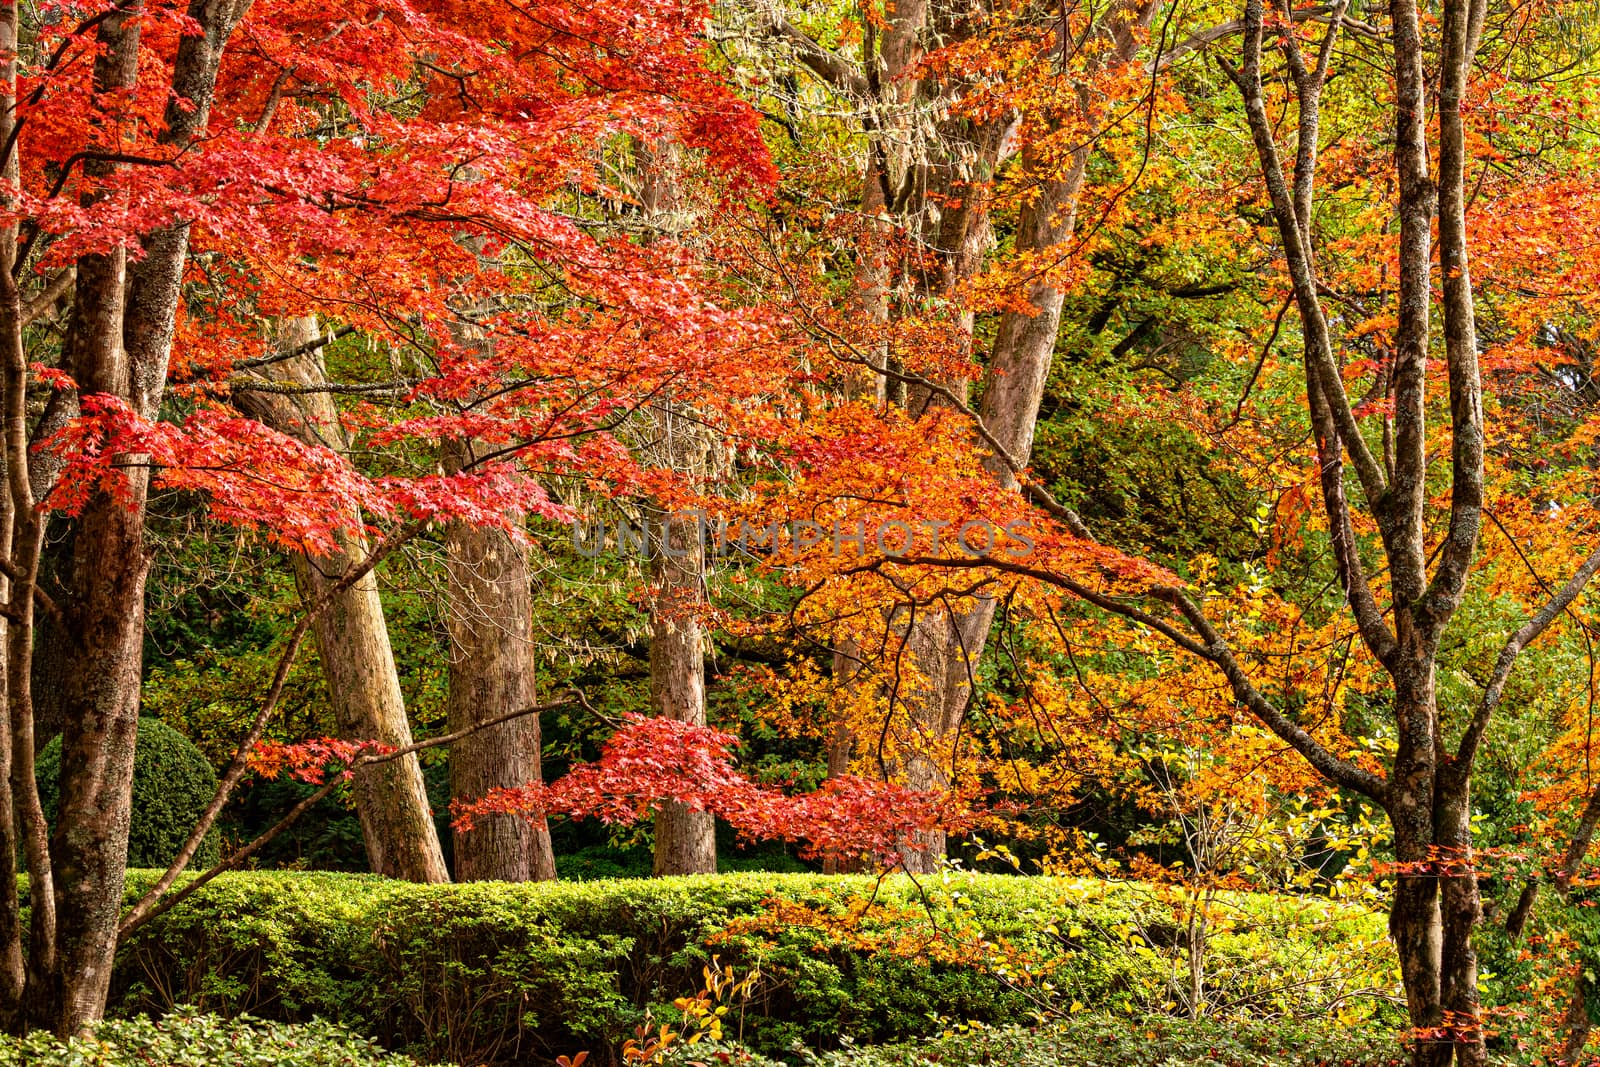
[732,2,1600,1064]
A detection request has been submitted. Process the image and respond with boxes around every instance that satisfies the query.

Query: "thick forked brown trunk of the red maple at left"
[31,0,250,1033]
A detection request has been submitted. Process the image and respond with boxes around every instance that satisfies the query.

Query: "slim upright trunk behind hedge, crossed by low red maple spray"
[650,518,717,875]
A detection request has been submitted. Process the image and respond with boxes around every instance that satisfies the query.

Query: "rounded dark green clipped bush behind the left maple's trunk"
[37,717,219,870]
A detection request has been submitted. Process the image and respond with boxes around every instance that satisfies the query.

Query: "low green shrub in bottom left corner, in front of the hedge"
[0,1013,416,1067]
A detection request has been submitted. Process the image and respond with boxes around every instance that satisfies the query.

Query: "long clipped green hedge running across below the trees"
[112,872,1394,1064]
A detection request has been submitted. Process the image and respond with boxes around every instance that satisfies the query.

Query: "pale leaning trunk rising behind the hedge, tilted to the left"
[237,318,450,881]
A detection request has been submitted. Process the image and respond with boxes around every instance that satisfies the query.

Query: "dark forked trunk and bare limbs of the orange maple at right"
[812,2,1600,1064]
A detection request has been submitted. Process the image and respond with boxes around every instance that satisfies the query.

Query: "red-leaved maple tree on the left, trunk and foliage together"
[0,0,774,1032]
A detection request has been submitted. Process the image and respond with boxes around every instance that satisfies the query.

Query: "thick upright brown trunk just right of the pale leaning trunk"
[445,445,555,881]
